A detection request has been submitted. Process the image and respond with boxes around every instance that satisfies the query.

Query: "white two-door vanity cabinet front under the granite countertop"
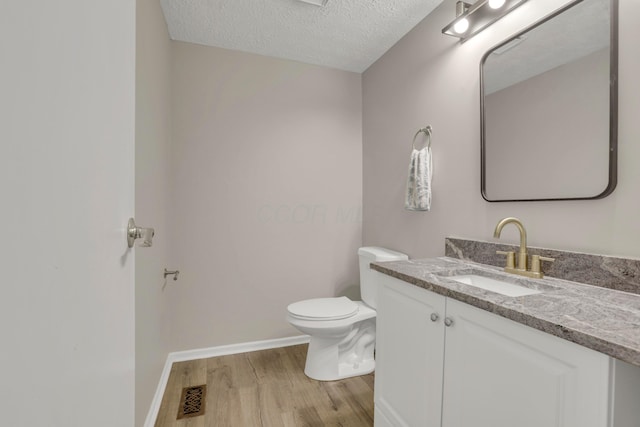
[375,274,612,427]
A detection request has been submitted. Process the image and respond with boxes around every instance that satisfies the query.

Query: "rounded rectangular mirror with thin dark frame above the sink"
[480,0,617,202]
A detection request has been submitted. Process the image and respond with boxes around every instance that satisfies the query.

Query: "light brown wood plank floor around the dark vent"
[156,344,374,427]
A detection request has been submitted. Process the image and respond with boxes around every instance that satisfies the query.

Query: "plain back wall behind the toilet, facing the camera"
[166,42,362,351]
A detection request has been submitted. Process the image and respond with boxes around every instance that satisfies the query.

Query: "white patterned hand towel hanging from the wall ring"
[404,146,433,211]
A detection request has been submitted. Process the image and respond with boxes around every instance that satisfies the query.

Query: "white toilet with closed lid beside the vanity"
[287,246,409,381]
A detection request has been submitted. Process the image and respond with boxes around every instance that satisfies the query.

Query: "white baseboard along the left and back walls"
[144,335,309,427]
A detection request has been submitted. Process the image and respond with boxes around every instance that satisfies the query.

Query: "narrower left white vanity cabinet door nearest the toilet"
[375,273,445,427]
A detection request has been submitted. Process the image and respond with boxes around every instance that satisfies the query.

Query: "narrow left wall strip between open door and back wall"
[135,0,171,426]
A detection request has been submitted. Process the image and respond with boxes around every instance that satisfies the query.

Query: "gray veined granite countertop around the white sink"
[371,257,640,366]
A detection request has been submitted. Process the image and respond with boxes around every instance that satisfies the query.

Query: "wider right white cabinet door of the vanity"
[442,299,610,427]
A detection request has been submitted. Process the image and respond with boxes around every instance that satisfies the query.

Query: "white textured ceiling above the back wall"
[161,0,444,73]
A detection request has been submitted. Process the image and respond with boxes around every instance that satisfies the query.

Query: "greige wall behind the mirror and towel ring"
[363,0,640,257]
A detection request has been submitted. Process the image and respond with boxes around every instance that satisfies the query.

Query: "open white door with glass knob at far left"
[0,0,135,427]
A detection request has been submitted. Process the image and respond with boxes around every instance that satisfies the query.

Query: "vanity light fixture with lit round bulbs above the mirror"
[442,0,527,42]
